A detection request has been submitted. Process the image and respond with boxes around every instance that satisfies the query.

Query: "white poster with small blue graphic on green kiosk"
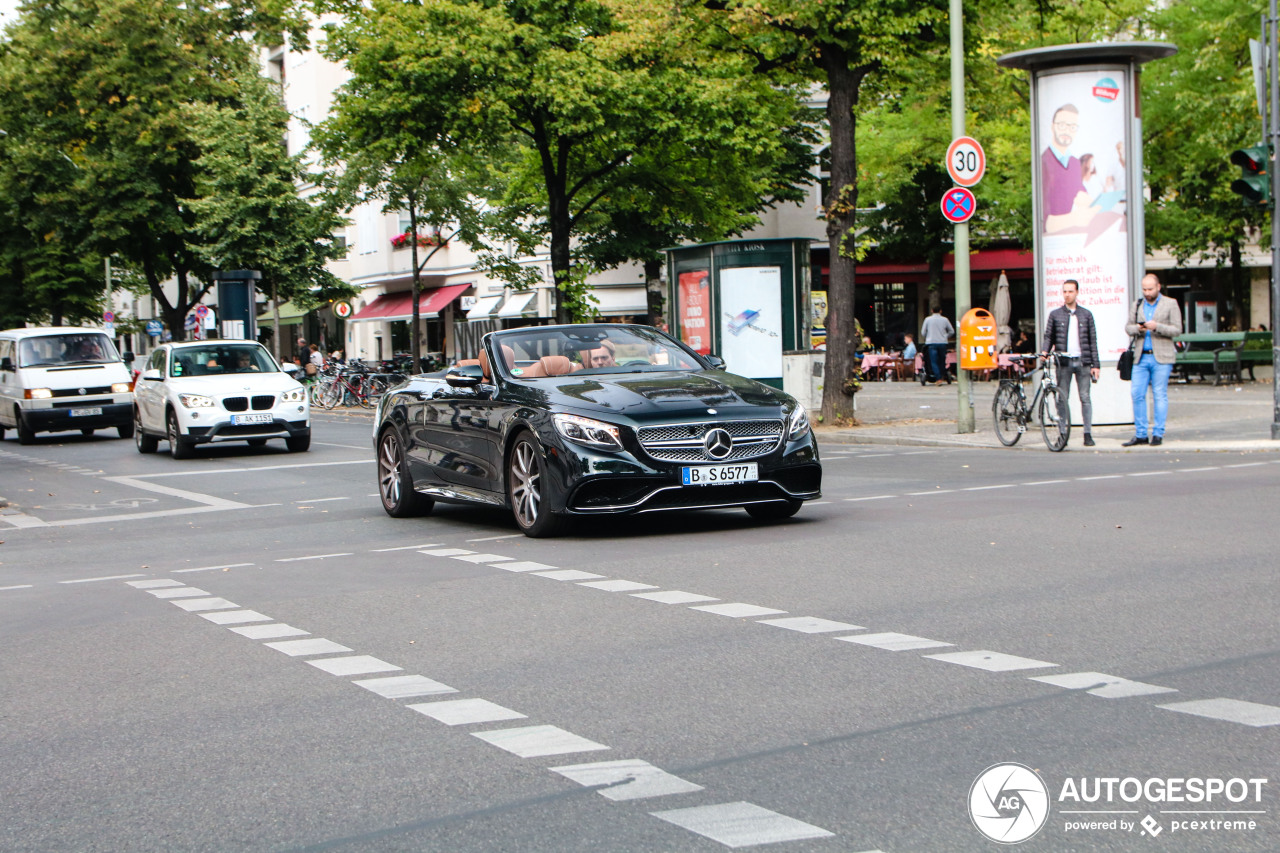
[719,266,782,379]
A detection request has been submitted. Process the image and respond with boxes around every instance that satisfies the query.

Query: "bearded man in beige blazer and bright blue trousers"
[1121,273,1183,447]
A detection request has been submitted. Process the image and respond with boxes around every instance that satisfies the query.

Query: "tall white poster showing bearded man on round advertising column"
[1034,68,1140,362]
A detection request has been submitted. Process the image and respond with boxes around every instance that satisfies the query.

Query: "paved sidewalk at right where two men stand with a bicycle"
[810,369,1280,453]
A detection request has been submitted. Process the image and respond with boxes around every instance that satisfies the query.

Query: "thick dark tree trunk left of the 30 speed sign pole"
[820,45,870,424]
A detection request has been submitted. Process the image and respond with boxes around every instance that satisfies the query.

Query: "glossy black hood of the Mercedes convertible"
[530,370,791,419]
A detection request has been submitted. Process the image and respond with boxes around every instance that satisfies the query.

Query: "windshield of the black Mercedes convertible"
[494,324,704,379]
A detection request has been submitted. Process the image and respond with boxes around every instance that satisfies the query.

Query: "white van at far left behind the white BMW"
[0,325,133,444]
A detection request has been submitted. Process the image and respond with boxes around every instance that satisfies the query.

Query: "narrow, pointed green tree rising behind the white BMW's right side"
[186,68,356,360]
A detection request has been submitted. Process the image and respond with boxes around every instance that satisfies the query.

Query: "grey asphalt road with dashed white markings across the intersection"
[0,415,1280,853]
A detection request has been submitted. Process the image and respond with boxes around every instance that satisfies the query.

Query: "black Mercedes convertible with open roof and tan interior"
[374,324,822,537]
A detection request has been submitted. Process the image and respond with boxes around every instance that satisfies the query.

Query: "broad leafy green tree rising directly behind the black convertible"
[321,0,796,321]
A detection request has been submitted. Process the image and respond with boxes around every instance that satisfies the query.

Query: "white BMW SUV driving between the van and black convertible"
[133,341,311,459]
